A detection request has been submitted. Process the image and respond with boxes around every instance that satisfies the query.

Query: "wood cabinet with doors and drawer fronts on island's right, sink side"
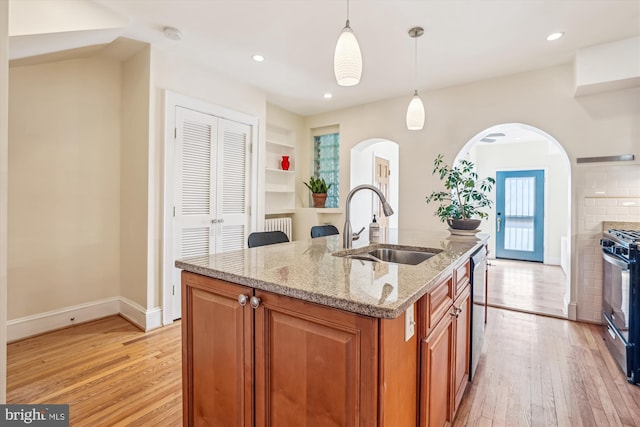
[418,262,471,427]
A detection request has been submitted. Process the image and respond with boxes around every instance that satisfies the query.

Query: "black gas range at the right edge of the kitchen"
[600,229,640,384]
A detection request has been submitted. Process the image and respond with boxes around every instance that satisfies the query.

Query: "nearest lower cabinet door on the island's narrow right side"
[419,313,453,427]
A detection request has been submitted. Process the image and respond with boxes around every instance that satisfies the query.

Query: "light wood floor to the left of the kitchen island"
[7,316,182,427]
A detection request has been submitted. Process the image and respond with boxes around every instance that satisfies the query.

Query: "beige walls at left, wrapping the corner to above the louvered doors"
[3,41,266,339]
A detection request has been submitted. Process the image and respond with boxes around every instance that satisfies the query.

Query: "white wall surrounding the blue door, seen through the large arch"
[470,140,570,265]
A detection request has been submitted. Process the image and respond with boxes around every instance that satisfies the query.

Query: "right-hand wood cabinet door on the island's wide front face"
[255,291,378,427]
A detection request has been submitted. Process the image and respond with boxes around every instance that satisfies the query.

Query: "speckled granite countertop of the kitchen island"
[175,229,489,319]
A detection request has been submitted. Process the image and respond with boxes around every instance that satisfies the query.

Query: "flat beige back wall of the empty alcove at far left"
[7,58,121,324]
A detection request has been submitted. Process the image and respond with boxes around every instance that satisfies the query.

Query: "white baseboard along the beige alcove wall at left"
[7,297,162,342]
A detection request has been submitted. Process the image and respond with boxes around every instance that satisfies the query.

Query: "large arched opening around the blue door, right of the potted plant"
[456,123,572,318]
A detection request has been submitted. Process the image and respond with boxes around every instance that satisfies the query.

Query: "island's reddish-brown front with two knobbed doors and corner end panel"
[182,272,418,427]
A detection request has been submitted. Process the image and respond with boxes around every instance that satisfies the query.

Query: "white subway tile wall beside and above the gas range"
[574,165,640,323]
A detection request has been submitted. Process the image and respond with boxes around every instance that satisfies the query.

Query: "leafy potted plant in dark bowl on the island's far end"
[426,154,496,230]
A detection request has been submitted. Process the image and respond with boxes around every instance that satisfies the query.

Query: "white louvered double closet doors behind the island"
[172,107,251,320]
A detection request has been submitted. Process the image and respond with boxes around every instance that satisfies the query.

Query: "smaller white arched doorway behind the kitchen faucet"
[350,138,400,232]
